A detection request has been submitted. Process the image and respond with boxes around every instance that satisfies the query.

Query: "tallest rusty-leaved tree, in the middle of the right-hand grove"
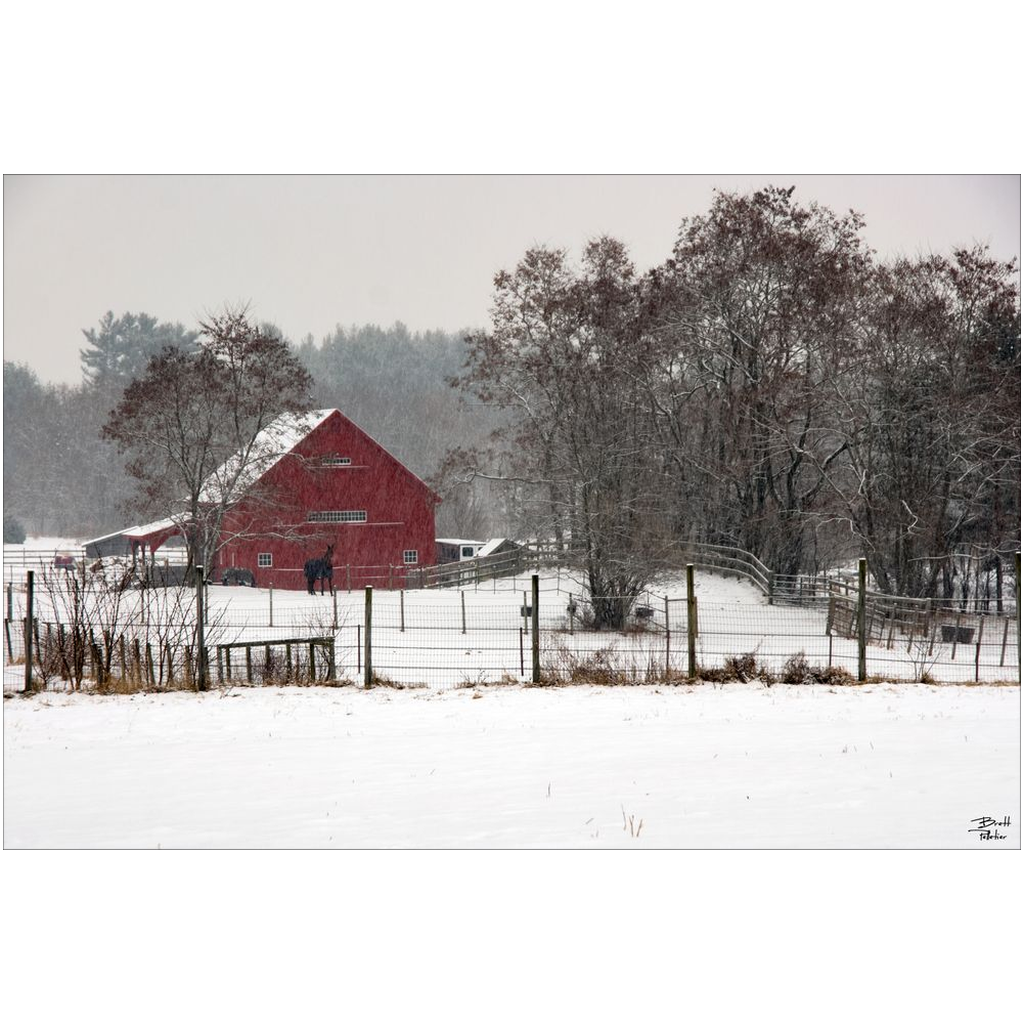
[645,187,869,572]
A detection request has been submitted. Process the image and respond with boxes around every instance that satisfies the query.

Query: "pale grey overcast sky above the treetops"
[3,175,1021,383]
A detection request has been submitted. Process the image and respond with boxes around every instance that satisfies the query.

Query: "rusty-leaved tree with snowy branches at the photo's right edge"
[831,249,1020,600]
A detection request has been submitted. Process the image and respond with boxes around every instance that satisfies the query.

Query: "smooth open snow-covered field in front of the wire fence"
[4,684,1020,849]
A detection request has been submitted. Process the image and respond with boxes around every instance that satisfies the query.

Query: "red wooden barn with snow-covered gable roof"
[205,409,439,590]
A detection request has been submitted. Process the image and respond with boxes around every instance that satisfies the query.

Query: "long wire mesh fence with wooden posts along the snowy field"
[4,574,1020,689]
